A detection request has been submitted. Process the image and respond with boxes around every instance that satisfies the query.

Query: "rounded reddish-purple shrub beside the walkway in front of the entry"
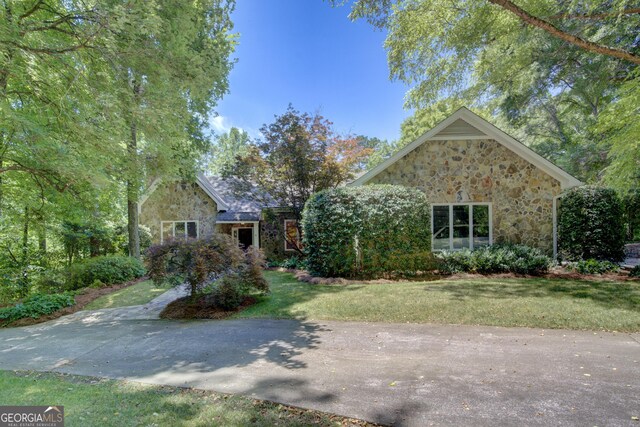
[146,234,269,310]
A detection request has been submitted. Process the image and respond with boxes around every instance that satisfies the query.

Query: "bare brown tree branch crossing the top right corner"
[489,0,640,64]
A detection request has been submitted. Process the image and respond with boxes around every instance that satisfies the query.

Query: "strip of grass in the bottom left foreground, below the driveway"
[0,371,367,427]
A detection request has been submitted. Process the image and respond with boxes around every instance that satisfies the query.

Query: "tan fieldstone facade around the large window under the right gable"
[368,139,561,252]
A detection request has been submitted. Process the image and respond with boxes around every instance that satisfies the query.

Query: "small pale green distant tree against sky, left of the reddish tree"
[207,127,251,175]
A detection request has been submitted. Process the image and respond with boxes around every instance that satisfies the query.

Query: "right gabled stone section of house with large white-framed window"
[348,108,582,255]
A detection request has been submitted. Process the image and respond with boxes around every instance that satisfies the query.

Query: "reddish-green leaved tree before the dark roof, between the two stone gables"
[231,105,370,251]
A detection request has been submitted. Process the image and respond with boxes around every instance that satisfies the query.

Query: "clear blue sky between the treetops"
[210,0,411,144]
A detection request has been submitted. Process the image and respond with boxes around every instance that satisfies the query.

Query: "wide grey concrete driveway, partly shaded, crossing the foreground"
[0,307,640,426]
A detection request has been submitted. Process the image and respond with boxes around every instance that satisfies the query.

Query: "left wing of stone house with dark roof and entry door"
[139,174,300,260]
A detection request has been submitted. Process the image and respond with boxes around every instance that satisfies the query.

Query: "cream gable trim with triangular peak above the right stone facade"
[347,107,582,190]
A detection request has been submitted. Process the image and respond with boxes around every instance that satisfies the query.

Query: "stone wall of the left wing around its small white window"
[140,183,218,243]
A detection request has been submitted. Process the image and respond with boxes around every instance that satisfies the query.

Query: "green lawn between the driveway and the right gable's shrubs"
[236,271,640,331]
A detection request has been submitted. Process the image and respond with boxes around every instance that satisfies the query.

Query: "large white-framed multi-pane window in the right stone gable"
[431,203,493,251]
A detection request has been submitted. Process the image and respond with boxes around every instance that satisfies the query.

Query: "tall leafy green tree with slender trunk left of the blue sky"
[104,0,234,258]
